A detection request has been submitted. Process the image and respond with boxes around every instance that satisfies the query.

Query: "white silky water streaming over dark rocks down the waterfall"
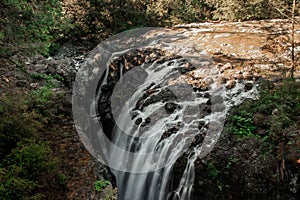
[98,51,256,200]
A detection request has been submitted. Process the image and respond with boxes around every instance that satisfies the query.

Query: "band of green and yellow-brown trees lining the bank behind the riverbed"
[0,0,298,57]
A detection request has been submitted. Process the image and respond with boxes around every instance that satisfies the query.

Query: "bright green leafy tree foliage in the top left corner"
[0,0,70,56]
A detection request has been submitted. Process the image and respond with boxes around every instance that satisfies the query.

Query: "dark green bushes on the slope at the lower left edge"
[0,93,65,200]
